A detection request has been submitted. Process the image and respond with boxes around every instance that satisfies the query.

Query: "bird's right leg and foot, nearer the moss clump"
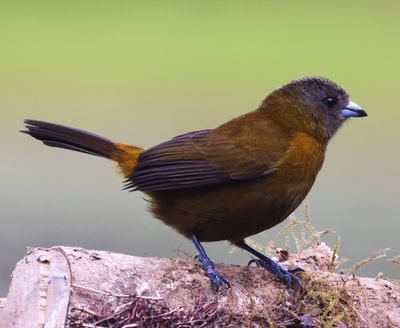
[235,240,304,288]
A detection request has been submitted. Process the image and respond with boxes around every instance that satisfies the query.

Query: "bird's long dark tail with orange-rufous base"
[21,120,143,177]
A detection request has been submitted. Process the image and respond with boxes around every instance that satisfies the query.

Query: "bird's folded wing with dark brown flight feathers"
[125,130,278,191]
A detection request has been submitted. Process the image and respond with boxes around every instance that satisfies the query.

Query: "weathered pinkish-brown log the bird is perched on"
[0,243,400,328]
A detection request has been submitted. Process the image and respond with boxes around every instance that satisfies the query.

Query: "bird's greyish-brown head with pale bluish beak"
[261,77,367,142]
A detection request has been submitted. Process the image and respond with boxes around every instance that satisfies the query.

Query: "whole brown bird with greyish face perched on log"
[22,77,367,289]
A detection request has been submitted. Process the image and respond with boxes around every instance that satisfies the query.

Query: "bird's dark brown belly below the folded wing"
[149,174,314,242]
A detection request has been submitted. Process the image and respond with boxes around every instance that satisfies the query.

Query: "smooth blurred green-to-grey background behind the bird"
[0,1,400,296]
